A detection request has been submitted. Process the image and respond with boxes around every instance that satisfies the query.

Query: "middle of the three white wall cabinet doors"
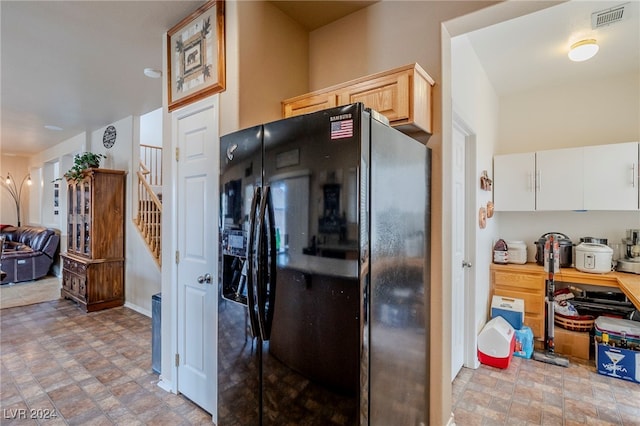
[536,148,584,210]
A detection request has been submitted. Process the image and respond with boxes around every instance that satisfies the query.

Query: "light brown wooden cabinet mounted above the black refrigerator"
[282,64,435,140]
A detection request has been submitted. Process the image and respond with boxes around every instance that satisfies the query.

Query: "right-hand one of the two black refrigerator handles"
[257,185,276,341]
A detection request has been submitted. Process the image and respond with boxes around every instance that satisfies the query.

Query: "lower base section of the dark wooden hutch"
[61,254,124,312]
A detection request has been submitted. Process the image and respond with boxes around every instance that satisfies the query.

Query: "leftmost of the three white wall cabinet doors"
[493,152,536,211]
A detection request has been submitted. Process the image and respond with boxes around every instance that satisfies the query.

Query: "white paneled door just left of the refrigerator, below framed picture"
[176,100,219,414]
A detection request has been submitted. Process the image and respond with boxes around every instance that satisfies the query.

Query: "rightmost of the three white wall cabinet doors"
[584,142,638,210]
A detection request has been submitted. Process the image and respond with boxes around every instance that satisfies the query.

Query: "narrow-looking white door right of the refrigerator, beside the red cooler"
[451,126,469,381]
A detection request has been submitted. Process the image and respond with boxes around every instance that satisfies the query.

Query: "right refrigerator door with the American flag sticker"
[263,105,362,426]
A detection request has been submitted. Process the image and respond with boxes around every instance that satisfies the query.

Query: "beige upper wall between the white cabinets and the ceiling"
[496,73,640,154]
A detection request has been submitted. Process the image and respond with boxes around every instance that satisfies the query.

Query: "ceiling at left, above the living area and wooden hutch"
[0,0,203,155]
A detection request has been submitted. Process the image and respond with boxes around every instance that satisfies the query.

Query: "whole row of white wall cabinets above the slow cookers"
[493,142,640,211]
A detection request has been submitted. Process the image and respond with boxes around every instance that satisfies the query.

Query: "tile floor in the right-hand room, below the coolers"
[453,357,640,426]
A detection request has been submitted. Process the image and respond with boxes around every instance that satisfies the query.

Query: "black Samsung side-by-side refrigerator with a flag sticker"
[217,103,431,426]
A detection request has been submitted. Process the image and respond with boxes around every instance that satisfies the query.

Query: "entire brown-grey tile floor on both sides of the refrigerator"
[0,286,640,426]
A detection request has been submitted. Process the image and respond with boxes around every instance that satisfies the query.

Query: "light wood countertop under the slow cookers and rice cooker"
[491,263,640,309]
